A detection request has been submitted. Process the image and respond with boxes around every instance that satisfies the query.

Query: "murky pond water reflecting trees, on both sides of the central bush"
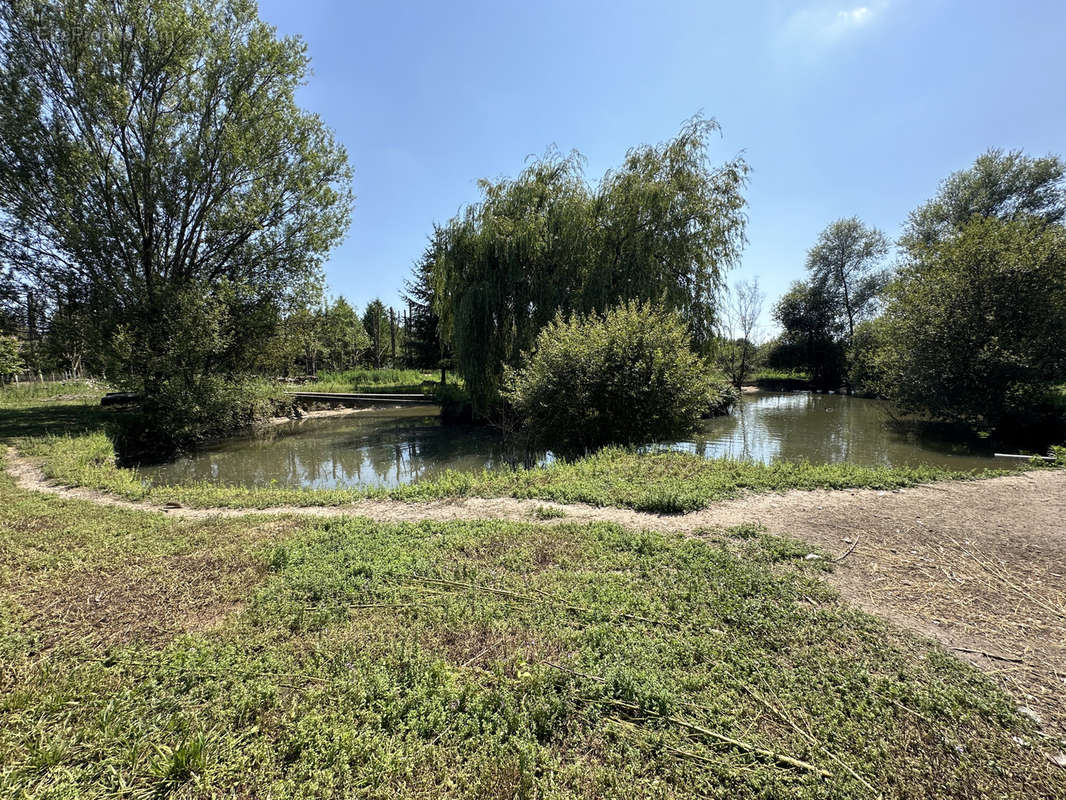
[141,391,1027,489]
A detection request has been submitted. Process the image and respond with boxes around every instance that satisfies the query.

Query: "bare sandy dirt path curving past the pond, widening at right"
[6,450,1066,765]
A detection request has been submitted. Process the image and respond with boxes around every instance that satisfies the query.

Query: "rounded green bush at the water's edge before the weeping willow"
[506,303,727,453]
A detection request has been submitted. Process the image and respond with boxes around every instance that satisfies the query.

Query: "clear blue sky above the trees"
[260,0,1066,332]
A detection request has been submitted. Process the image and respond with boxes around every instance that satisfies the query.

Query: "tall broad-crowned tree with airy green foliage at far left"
[0,0,351,437]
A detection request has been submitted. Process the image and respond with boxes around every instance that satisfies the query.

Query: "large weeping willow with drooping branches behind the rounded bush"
[433,116,748,414]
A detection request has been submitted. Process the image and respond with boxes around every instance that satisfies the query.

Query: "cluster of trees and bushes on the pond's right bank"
[765,149,1066,434]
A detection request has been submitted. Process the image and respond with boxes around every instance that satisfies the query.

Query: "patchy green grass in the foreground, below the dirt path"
[0,460,1063,798]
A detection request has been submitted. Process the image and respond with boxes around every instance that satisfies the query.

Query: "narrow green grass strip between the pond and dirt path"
[19,431,1023,513]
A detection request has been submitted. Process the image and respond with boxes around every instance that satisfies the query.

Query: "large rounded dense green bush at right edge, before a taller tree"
[881,217,1066,431]
